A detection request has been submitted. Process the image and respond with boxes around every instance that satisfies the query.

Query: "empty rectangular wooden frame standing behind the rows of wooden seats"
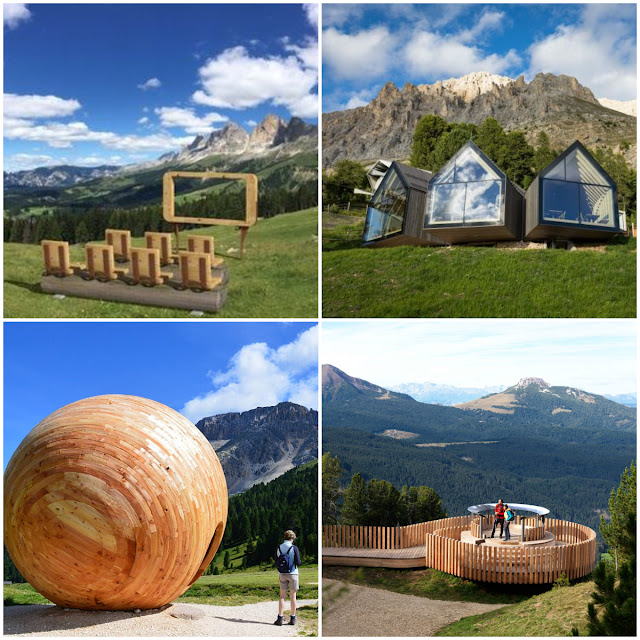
[162,171,258,228]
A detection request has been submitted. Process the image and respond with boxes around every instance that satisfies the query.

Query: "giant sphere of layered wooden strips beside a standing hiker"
[4,395,228,610]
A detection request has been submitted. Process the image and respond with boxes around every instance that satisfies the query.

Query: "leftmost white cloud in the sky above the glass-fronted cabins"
[322,27,396,80]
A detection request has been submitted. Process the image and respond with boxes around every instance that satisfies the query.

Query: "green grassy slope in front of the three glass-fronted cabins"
[322,219,636,318]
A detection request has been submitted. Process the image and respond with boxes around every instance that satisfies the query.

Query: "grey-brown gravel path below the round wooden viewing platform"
[322,579,504,637]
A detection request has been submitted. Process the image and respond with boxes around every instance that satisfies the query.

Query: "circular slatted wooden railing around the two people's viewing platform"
[426,518,596,584]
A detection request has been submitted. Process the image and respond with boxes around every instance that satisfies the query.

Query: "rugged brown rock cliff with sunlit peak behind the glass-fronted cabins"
[322,73,636,167]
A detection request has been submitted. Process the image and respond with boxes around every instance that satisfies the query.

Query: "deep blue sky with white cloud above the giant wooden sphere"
[4,322,318,467]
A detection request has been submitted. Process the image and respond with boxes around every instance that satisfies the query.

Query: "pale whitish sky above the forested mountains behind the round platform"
[322,319,637,395]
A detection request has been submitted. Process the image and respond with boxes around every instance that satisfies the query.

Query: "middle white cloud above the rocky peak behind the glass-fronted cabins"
[404,31,521,78]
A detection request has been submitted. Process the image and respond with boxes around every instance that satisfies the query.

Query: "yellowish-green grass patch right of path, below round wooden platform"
[436,582,595,637]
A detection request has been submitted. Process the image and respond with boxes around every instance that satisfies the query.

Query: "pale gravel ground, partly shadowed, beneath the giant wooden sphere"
[4,600,317,637]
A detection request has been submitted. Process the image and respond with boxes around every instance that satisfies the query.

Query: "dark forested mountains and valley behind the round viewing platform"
[322,365,636,531]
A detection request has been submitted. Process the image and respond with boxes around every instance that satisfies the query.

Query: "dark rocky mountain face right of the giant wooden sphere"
[196,402,318,494]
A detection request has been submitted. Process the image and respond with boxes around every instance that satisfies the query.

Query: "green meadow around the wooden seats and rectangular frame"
[4,209,318,318]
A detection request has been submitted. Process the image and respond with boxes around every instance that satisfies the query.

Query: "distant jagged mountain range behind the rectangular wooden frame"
[4,114,318,190]
